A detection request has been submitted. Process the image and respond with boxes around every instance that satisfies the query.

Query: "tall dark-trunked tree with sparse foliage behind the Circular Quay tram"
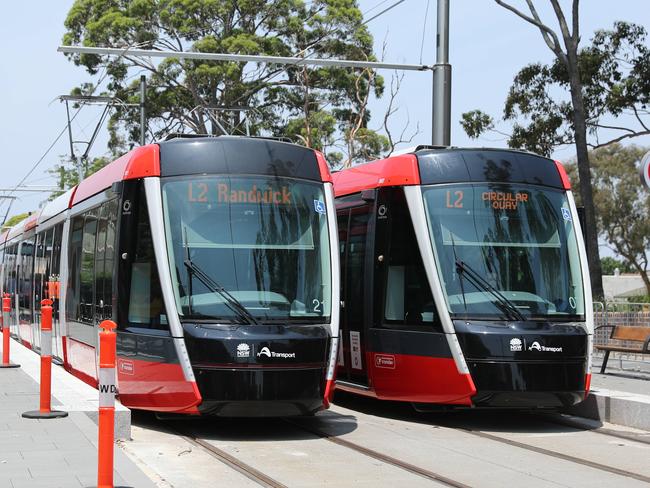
[461,0,650,297]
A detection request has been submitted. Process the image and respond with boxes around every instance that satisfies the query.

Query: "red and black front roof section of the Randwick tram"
[69,136,332,207]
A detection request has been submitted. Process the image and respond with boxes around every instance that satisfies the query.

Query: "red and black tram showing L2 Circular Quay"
[333,146,593,410]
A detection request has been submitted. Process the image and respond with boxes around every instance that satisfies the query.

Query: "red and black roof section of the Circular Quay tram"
[332,146,571,197]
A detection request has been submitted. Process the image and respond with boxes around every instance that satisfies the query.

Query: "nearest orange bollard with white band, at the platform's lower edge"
[97,320,117,488]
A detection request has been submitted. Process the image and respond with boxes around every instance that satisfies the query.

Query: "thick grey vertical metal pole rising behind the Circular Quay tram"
[431,0,451,146]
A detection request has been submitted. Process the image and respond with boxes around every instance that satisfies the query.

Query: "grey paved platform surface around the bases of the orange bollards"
[0,341,155,488]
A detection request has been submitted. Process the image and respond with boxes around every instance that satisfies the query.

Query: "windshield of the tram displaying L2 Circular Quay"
[423,183,584,320]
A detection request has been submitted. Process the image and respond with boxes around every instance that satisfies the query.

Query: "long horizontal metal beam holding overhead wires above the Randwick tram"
[57,46,433,71]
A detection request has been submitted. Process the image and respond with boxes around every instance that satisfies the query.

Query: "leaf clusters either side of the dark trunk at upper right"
[461,22,650,155]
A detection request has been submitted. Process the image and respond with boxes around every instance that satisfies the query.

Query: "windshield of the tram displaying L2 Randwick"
[162,176,331,323]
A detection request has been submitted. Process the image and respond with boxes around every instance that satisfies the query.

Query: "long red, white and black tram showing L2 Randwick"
[0,136,340,416]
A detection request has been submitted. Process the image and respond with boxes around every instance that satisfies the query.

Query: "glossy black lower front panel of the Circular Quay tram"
[454,321,588,408]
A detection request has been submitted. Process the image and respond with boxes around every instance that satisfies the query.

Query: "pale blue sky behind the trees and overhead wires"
[0,0,650,221]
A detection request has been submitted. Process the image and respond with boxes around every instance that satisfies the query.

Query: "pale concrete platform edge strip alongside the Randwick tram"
[0,340,131,439]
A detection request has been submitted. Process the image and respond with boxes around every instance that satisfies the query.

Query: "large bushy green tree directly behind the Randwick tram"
[63,0,390,164]
